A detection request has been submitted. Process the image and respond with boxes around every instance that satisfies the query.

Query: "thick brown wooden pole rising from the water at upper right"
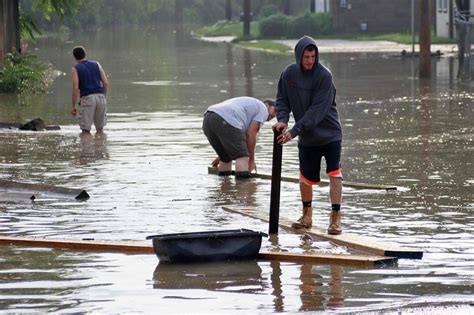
[420,0,431,78]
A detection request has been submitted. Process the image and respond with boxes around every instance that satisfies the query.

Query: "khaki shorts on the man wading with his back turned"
[79,94,107,130]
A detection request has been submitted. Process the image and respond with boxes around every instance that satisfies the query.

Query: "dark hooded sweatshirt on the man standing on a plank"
[276,36,342,146]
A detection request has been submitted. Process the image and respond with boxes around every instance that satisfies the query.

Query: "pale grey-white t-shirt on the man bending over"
[207,96,268,131]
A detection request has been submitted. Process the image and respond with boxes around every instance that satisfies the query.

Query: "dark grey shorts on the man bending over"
[202,112,249,162]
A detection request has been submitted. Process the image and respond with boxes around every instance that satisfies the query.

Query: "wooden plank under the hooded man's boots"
[222,207,423,259]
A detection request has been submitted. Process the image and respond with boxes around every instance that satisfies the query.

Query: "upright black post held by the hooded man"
[268,131,283,234]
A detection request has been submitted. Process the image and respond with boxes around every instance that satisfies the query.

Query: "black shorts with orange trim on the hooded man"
[298,141,342,185]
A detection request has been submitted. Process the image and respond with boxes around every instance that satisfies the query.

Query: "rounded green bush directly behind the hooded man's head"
[290,12,332,37]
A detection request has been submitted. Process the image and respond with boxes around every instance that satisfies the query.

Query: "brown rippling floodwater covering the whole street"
[0,29,474,314]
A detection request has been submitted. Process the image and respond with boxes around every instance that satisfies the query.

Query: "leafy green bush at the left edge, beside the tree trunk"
[0,53,47,93]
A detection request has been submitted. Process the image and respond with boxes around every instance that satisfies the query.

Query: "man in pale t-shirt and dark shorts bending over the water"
[202,96,276,178]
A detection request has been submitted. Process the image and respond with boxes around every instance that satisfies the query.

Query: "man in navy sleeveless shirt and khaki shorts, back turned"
[71,46,109,133]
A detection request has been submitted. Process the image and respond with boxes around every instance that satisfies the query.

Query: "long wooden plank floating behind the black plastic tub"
[0,236,397,267]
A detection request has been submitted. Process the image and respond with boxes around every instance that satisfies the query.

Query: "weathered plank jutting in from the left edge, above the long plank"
[0,179,90,201]
